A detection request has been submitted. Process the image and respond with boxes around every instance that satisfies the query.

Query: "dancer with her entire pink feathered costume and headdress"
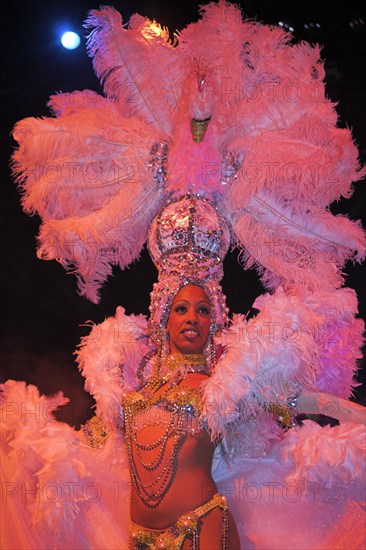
[2,1,365,550]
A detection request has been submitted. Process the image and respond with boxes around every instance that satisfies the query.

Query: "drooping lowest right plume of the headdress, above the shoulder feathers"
[233,193,365,290]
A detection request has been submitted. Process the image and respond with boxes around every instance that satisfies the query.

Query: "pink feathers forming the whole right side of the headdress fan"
[216,7,365,290]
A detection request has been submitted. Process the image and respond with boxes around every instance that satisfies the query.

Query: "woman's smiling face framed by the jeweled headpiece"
[167,285,211,355]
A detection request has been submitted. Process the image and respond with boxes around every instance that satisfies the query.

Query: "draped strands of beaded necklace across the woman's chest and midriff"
[123,355,208,508]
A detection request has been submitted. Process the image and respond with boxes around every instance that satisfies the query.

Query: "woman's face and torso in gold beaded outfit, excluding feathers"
[124,285,240,550]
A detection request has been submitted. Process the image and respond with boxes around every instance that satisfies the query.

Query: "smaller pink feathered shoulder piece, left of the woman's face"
[76,307,152,430]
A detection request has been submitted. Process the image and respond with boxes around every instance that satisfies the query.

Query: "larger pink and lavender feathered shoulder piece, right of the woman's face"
[203,288,364,446]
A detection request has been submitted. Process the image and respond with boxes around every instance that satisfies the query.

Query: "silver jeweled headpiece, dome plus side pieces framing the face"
[148,195,230,340]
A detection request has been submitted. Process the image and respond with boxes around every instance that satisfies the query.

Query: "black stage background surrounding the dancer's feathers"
[0,0,366,425]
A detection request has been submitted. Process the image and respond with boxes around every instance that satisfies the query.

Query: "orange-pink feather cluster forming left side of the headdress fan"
[13,91,165,302]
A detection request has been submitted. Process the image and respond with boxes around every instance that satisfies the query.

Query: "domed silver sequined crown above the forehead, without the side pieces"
[149,195,230,281]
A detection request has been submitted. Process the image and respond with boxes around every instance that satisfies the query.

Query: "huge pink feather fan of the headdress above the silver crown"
[13,1,365,320]
